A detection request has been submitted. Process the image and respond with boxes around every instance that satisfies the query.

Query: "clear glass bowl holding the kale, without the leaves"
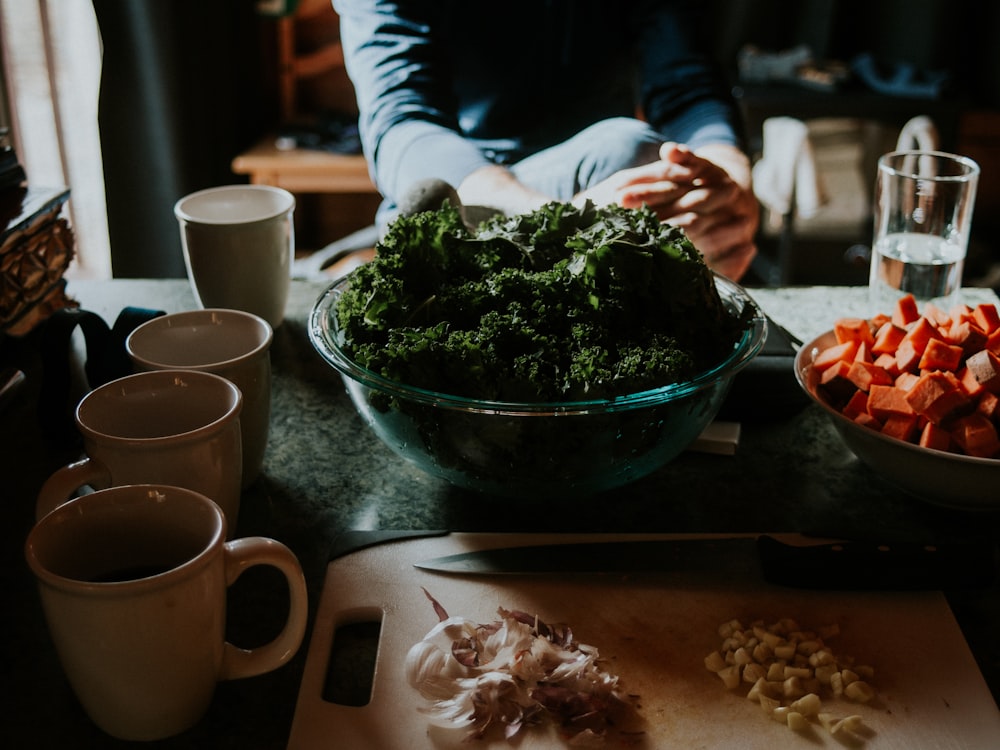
[309,275,767,497]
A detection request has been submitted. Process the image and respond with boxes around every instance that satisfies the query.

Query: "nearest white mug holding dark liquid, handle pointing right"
[25,485,308,740]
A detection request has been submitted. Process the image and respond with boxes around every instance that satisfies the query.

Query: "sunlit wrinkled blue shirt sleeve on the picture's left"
[334,0,490,203]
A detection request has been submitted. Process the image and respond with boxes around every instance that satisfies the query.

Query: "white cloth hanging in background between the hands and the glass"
[753,117,826,219]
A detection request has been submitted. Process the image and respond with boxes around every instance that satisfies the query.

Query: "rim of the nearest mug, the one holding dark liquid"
[24,484,227,596]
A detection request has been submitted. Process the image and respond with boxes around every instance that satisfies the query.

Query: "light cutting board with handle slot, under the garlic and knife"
[288,534,1000,750]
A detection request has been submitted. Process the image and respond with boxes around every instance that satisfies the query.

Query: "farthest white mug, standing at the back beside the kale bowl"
[174,185,295,328]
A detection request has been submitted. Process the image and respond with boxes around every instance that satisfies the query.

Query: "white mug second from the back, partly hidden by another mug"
[125,309,274,487]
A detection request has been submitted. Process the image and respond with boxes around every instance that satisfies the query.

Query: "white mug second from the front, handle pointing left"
[36,370,243,530]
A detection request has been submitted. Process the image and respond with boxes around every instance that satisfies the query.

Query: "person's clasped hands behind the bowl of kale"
[575,142,760,280]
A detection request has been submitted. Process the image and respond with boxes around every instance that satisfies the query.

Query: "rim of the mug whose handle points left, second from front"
[74,368,243,446]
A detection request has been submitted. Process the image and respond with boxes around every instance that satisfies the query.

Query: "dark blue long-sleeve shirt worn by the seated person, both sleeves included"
[333,0,738,202]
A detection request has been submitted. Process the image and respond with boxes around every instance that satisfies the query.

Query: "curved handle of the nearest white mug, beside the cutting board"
[219,536,309,680]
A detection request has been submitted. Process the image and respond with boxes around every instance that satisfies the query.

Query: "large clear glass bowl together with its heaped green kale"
[309,203,766,497]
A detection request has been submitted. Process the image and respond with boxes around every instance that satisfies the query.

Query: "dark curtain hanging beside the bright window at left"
[93,0,267,278]
